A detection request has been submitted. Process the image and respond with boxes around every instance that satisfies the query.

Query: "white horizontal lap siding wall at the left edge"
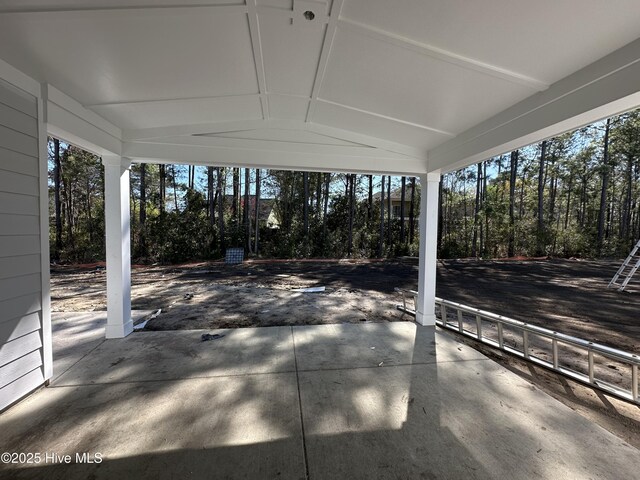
[0,80,45,410]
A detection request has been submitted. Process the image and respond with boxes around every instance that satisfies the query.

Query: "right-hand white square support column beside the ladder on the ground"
[416,171,440,326]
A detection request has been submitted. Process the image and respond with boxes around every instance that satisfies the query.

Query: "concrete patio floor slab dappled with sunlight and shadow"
[0,314,640,479]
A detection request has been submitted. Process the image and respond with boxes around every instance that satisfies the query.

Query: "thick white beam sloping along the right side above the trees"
[428,39,640,171]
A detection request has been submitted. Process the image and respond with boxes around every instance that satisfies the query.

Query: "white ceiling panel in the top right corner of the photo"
[342,0,640,84]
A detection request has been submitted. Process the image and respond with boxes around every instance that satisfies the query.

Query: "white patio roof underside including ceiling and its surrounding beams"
[0,0,640,175]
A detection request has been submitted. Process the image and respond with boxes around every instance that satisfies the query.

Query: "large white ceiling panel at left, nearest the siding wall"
[0,2,258,105]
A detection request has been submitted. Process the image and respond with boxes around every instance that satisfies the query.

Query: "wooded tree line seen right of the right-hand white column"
[439,111,640,257]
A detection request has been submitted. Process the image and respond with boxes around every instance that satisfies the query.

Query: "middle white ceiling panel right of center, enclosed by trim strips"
[320,28,536,134]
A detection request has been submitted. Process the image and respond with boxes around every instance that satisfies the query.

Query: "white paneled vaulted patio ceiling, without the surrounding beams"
[0,0,640,170]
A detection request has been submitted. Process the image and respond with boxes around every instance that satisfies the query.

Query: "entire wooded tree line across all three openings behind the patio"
[49,112,640,262]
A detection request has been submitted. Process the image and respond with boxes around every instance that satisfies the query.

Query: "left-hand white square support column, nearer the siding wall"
[102,156,133,338]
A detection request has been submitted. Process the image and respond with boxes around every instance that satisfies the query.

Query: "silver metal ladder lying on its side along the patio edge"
[395,288,640,405]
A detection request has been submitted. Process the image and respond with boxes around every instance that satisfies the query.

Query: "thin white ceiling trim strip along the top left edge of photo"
[0,2,247,14]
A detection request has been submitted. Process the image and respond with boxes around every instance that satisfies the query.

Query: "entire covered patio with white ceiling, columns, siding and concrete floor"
[0,0,640,479]
